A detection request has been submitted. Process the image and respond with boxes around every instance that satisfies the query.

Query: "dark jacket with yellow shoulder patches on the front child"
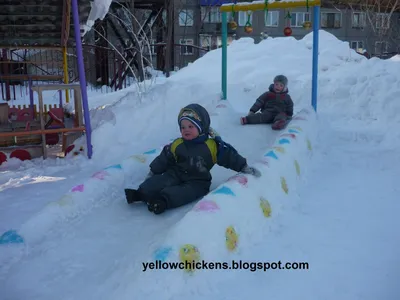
[150,138,246,185]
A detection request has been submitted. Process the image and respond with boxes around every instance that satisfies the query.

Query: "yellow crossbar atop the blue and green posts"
[219,0,321,12]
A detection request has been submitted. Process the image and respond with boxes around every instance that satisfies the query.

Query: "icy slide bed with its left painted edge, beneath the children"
[0,101,286,299]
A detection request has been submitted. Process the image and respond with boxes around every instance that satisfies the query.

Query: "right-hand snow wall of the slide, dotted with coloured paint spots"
[123,104,317,299]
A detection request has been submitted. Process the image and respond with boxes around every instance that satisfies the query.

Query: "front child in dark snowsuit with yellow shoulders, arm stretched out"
[125,104,261,214]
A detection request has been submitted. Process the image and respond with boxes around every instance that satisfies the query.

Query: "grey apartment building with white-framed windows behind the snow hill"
[174,0,400,67]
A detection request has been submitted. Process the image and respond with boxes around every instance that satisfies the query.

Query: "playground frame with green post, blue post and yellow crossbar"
[220,0,321,111]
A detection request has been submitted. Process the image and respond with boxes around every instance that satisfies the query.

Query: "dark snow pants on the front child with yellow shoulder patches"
[138,172,211,209]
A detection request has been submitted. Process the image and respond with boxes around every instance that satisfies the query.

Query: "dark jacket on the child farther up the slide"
[250,84,293,117]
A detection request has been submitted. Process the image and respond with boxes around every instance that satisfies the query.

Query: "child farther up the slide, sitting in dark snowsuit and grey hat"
[240,75,293,129]
